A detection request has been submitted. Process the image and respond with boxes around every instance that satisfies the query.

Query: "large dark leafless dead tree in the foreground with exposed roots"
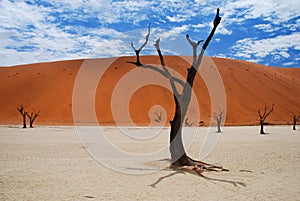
[132,9,225,171]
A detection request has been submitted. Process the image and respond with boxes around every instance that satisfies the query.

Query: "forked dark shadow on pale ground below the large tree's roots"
[149,168,246,188]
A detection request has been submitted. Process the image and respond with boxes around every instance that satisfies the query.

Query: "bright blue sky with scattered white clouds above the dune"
[0,0,300,67]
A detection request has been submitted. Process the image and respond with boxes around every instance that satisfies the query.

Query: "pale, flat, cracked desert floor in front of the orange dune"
[0,126,300,200]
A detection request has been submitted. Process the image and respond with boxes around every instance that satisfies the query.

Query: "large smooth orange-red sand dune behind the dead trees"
[0,56,300,126]
